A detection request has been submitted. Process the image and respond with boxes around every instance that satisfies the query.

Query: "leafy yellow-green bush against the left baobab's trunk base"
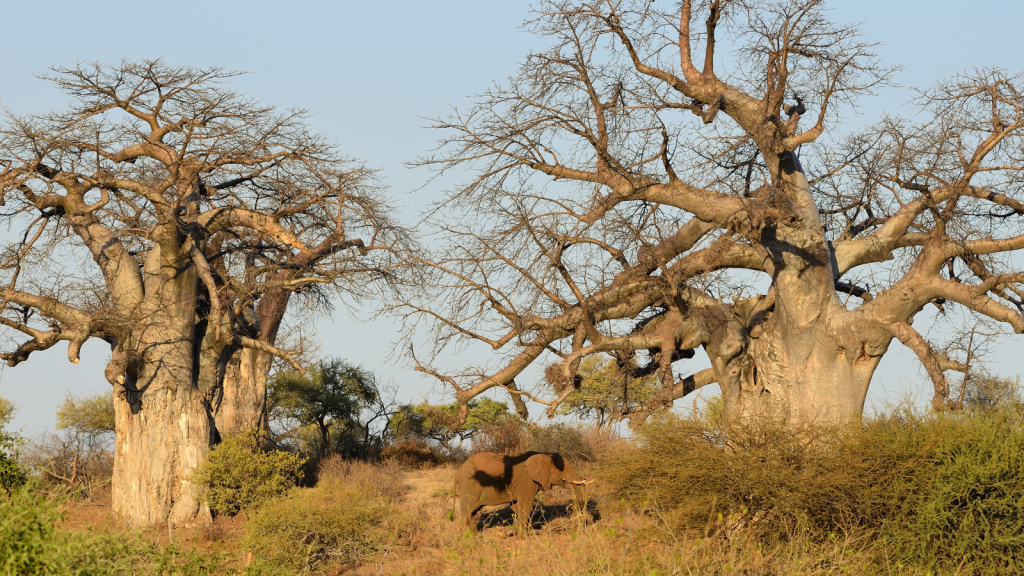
[193,431,306,515]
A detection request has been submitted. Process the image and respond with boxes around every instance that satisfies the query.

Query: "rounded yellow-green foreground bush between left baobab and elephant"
[246,478,401,570]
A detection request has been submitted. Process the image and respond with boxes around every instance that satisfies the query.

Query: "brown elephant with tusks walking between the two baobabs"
[454,452,591,534]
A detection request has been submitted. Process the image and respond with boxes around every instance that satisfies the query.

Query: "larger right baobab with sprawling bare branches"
[394,0,1024,425]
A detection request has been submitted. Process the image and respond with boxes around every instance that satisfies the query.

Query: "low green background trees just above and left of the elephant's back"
[389,398,516,457]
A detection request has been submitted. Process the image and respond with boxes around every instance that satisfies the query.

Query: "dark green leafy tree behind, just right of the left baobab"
[267,359,382,455]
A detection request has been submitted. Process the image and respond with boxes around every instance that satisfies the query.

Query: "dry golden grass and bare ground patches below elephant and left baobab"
[44,460,925,576]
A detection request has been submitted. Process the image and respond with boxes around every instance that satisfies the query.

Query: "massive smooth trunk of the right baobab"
[707,161,892,425]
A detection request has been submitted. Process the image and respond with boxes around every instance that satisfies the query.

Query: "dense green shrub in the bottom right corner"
[849,406,1024,574]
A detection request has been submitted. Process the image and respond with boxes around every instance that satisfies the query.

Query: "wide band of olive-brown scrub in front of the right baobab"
[600,391,1024,574]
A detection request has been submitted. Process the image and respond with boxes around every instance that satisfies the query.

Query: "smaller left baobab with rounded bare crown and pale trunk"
[0,60,406,526]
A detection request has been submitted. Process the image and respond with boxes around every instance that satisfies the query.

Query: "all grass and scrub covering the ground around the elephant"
[9,381,1024,576]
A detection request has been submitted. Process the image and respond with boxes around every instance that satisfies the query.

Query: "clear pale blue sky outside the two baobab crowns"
[0,0,1024,434]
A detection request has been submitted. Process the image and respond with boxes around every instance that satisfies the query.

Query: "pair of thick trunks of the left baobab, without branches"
[109,264,296,527]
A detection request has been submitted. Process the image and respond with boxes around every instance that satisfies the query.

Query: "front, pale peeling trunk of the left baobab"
[108,247,215,528]
